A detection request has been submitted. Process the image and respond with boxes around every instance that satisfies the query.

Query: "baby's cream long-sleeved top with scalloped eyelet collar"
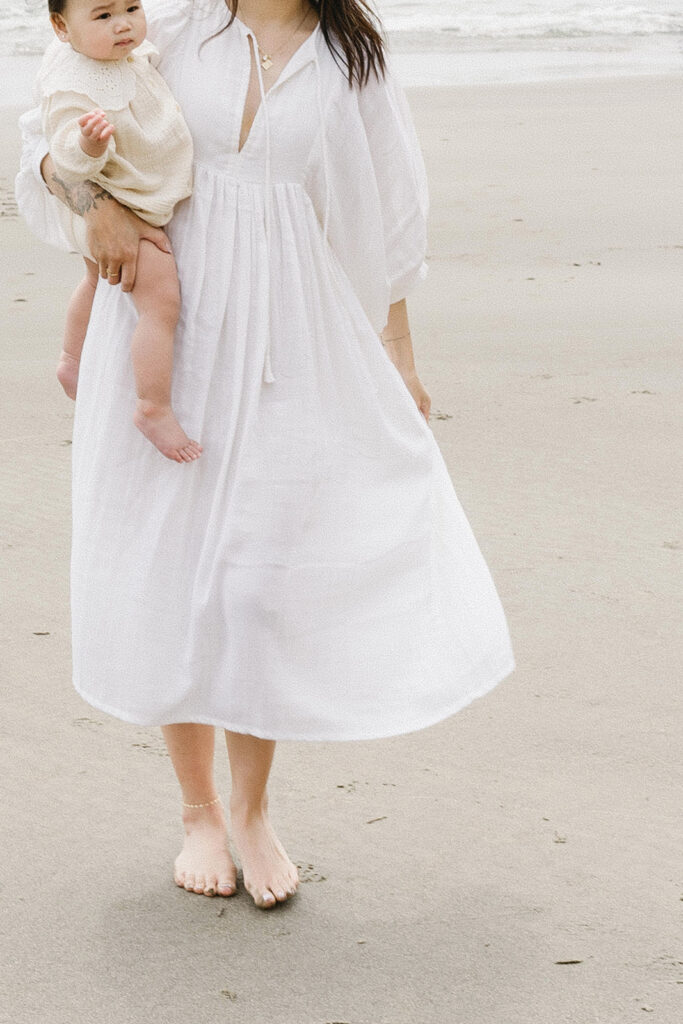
[38,39,193,227]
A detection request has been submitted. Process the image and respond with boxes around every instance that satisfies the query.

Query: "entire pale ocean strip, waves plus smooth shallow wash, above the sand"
[0,0,683,100]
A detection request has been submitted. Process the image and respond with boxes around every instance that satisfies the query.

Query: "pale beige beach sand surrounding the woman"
[0,77,683,1024]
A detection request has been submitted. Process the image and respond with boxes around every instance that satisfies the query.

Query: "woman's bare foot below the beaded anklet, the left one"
[173,804,237,896]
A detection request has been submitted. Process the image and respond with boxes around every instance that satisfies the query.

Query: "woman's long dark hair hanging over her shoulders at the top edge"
[206,0,385,85]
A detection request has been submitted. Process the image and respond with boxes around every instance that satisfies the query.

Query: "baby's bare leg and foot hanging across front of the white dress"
[131,239,202,462]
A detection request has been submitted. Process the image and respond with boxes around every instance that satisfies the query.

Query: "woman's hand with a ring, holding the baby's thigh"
[84,199,171,292]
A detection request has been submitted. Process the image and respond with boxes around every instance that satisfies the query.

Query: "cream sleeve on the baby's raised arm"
[44,92,116,184]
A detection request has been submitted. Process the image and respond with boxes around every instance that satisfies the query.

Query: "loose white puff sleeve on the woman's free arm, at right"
[305,61,428,334]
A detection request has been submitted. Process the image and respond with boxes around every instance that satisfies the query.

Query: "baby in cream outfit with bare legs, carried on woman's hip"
[38,0,202,462]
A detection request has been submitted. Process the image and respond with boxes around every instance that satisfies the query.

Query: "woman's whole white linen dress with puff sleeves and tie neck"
[17,0,515,740]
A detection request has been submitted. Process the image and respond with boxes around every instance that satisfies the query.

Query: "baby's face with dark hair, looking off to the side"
[51,0,147,60]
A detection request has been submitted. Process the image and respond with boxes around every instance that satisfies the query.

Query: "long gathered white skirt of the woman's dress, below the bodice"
[72,165,514,740]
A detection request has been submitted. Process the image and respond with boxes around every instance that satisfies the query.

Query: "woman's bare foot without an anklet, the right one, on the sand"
[231,808,299,909]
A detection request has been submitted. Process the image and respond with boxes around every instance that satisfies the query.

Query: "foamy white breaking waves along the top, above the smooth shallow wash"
[0,0,683,54]
